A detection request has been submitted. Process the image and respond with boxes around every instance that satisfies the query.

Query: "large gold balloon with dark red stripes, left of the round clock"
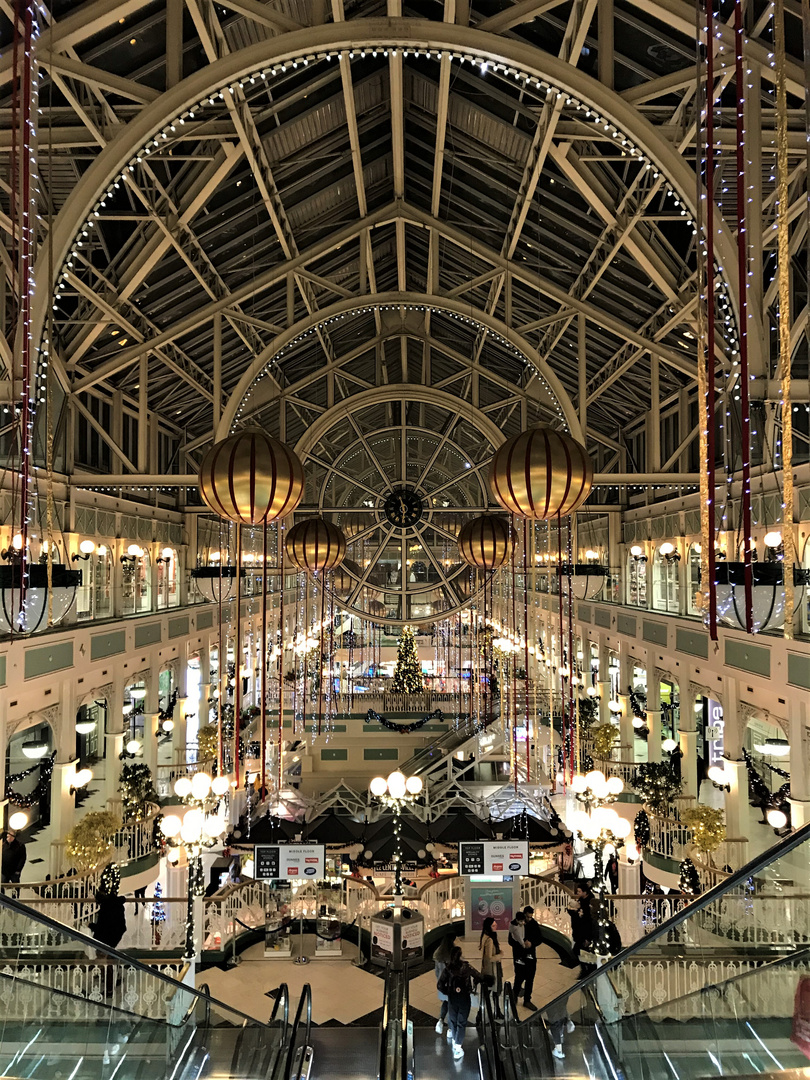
[200,428,303,525]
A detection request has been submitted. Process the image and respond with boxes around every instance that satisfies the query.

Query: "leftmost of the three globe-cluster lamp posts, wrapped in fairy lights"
[160,772,230,961]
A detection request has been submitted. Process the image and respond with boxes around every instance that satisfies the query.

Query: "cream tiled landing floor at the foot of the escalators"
[197,940,576,1024]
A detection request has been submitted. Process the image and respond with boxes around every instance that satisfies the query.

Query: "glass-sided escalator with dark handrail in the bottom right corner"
[481,825,810,1080]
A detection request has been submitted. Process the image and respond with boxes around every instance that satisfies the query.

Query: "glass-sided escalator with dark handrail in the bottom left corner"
[0,896,302,1080]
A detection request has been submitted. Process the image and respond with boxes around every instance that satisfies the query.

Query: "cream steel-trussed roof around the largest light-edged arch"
[0,0,804,486]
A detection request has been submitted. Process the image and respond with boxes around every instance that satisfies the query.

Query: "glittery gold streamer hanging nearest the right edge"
[773,0,796,638]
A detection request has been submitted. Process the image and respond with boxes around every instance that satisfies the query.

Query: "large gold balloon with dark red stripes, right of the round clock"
[489,427,593,521]
